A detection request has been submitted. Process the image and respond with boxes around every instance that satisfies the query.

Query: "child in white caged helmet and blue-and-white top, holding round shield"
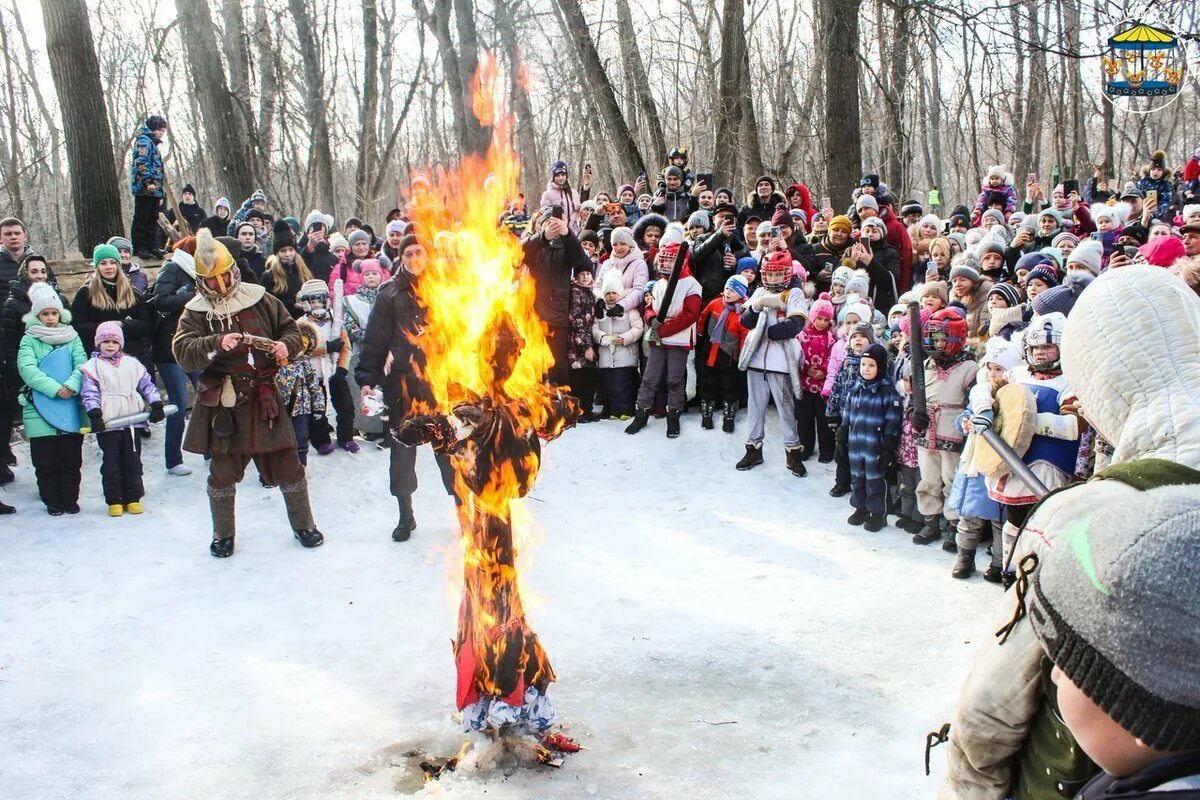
[971,312,1087,578]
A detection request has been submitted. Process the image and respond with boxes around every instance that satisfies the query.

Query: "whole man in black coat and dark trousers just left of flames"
[354,237,457,542]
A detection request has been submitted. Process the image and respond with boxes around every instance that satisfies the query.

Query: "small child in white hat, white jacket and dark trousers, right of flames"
[592,270,644,420]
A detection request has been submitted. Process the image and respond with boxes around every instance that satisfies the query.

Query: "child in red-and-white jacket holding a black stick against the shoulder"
[625,225,701,439]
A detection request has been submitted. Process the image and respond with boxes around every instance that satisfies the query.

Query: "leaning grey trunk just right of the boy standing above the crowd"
[175,0,257,203]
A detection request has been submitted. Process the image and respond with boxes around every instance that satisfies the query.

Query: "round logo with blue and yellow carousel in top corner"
[1100,19,1187,114]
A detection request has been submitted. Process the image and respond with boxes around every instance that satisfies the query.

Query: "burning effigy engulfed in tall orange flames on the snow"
[400,55,577,733]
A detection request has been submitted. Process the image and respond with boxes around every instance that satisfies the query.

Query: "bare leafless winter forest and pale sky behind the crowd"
[7,0,1200,257]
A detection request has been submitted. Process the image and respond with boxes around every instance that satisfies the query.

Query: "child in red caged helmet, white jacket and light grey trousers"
[737,249,808,477]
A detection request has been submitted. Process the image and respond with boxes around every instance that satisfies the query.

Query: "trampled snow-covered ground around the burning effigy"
[0,415,1001,800]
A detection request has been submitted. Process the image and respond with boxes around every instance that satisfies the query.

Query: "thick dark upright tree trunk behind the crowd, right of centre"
[817,0,863,207]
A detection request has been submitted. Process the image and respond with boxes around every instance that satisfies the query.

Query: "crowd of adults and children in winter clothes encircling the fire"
[0,118,1200,796]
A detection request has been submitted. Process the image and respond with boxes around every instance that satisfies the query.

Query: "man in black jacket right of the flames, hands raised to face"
[523,206,587,386]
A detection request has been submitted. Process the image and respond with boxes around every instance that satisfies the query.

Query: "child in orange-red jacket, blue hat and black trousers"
[696,275,750,433]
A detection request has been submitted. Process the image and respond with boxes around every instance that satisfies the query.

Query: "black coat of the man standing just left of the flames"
[354,270,433,419]
